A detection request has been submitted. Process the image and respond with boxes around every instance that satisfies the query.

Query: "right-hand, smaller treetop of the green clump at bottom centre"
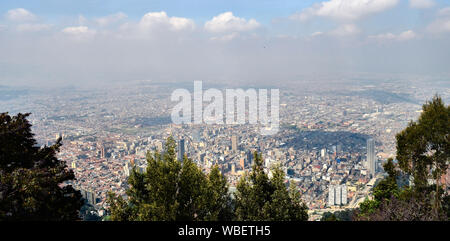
[236,152,308,221]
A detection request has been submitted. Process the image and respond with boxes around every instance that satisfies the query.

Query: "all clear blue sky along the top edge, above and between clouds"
[0,0,450,34]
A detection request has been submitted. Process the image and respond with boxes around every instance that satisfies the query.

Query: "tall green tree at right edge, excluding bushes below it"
[396,96,450,214]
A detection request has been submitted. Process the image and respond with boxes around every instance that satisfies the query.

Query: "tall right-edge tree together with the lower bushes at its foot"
[358,96,450,221]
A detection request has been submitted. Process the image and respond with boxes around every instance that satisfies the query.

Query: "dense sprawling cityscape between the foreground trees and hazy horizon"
[0,74,450,220]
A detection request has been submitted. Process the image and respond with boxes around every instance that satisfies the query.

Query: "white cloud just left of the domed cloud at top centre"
[139,12,195,31]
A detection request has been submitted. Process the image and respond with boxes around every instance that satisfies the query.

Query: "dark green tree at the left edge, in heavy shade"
[0,113,83,220]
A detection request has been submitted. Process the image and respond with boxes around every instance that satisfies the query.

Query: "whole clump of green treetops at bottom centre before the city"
[108,137,308,221]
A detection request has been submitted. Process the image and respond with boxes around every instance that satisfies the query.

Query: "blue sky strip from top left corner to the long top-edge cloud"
[0,0,317,23]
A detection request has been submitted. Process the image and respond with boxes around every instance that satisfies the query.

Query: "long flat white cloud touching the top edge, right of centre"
[290,0,398,20]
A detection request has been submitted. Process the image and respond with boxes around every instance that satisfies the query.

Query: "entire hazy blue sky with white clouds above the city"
[0,0,450,87]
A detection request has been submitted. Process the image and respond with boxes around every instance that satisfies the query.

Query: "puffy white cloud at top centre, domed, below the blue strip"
[205,12,260,33]
